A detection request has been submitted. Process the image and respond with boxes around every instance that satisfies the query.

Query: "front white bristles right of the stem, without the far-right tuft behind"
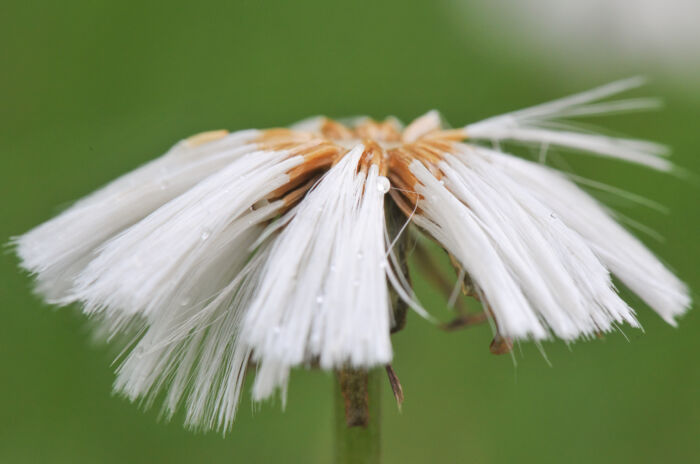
[411,155,637,340]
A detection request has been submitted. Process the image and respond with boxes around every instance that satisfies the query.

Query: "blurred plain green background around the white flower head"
[0,0,700,464]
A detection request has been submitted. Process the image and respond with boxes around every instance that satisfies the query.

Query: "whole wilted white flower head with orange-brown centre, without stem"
[10,79,690,430]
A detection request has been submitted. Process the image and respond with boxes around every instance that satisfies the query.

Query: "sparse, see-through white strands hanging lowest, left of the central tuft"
[115,243,270,432]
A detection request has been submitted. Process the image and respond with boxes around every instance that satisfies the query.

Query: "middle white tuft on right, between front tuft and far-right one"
[448,152,638,340]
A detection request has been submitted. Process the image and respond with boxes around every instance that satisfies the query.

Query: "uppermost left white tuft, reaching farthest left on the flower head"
[14,130,259,303]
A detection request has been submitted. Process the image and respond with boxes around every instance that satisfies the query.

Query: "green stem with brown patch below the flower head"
[334,369,381,464]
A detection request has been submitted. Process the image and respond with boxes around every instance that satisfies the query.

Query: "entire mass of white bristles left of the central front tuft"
[13,131,304,431]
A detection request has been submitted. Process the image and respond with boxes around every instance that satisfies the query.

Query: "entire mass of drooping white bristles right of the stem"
[411,139,688,340]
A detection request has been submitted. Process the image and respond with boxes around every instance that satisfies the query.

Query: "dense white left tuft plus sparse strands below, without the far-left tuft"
[85,151,303,431]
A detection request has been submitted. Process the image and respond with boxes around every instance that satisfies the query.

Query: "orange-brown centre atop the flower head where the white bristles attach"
[257,118,467,216]
